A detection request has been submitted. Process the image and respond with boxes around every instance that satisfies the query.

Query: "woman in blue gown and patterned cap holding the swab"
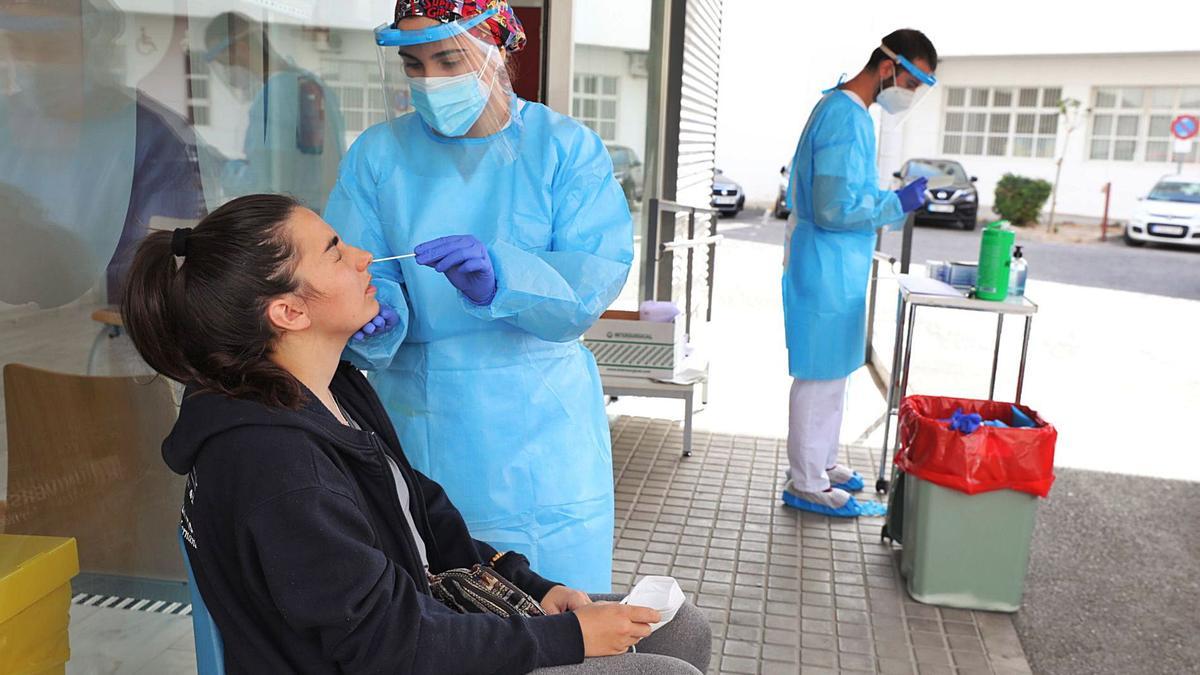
[325,0,632,592]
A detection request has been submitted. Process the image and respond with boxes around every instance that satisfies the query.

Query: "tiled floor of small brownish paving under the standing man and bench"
[68,417,1030,675]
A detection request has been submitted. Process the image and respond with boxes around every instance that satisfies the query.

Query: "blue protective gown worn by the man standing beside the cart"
[784,90,904,380]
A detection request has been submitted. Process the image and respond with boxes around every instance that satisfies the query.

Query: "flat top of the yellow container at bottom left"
[0,534,79,623]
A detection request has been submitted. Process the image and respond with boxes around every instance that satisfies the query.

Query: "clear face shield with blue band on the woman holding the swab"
[374,10,520,159]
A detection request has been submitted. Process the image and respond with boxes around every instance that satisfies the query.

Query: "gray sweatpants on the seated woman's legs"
[533,596,713,675]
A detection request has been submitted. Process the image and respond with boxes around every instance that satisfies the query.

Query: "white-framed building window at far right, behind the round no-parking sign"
[1087,86,1200,162]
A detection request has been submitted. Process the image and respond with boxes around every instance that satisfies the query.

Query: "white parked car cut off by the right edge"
[1124,175,1200,246]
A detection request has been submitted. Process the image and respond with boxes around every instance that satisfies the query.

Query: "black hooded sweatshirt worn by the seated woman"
[162,363,583,674]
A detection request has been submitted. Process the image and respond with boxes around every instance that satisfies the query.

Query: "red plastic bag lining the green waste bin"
[895,396,1058,497]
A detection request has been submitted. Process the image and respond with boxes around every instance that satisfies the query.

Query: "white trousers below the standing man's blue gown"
[787,377,846,492]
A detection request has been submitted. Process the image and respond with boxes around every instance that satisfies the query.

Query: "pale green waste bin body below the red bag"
[900,473,1038,611]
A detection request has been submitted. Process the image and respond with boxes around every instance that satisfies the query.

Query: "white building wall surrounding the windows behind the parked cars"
[880,53,1200,219]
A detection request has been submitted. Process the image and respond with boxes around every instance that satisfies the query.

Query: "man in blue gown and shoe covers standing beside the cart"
[782,30,937,516]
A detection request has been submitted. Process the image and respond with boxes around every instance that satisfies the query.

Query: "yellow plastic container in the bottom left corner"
[0,534,79,675]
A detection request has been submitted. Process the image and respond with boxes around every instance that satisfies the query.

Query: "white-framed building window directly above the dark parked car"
[942,86,1062,157]
